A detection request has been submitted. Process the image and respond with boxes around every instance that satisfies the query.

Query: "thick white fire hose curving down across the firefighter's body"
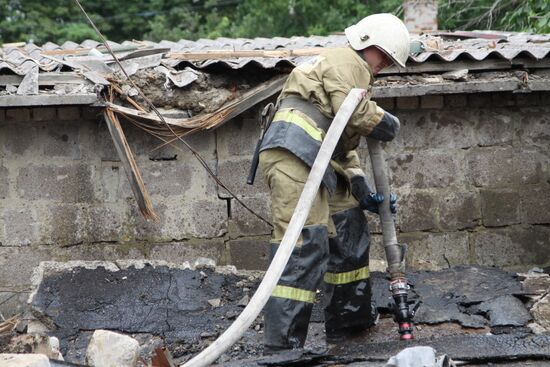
[182,89,366,367]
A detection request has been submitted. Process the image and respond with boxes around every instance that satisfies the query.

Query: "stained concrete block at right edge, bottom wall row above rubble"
[472,226,550,270]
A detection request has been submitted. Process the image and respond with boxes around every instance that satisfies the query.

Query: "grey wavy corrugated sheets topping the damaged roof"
[0,32,550,75]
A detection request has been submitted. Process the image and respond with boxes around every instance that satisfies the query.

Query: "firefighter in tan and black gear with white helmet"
[260,14,409,353]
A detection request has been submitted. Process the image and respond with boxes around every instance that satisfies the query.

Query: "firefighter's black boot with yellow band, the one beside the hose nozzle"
[325,208,378,341]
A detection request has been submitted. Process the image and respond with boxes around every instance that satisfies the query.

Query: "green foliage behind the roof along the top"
[0,0,550,44]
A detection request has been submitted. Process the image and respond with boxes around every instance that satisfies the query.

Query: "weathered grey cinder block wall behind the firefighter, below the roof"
[0,93,550,315]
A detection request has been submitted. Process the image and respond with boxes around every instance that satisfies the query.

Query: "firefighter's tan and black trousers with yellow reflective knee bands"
[260,149,375,351]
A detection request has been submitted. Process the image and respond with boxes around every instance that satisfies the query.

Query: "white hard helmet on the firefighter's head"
[346,13,410,67]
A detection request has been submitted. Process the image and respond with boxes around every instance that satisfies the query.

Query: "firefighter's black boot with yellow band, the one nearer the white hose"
[264,226,328,354]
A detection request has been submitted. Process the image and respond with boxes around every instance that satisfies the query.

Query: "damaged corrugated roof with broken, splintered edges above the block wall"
[0,31,550,106]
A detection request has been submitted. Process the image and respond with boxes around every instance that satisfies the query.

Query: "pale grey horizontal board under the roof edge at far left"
[0,93,100,107]
